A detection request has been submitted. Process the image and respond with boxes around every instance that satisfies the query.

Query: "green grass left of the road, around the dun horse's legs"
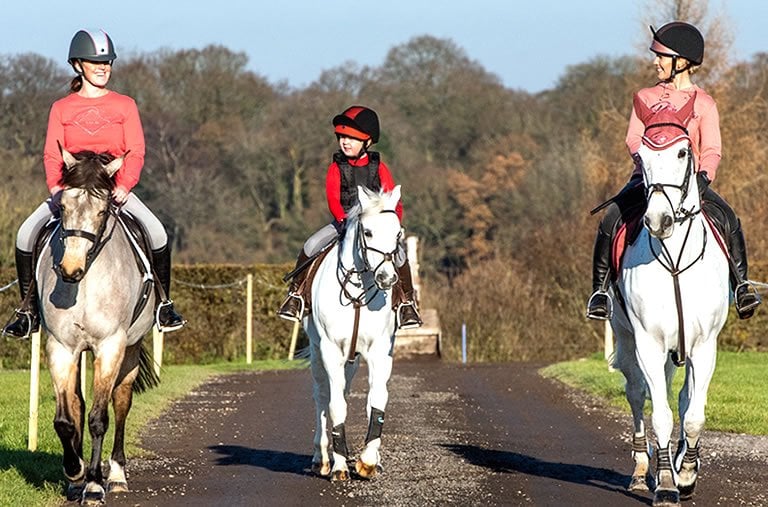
[0,361,306,506]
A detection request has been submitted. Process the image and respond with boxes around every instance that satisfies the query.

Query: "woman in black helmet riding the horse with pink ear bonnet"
[587,21,760,320]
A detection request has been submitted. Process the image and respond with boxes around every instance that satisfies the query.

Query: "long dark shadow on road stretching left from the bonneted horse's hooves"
[443,444,652,505]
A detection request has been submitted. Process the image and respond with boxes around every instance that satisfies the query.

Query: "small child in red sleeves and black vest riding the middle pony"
[277,106,421,329]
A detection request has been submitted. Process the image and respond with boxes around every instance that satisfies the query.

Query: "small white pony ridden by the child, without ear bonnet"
[304,185,402,481]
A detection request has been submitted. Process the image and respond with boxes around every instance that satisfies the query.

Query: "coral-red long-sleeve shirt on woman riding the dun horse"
[43,91,145,194]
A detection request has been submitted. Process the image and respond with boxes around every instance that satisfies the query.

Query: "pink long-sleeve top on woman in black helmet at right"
[626,83,722,181]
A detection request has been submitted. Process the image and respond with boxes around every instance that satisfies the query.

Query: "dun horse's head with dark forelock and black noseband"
[57,148,123,283]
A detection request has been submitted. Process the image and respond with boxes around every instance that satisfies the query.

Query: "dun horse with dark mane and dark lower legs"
[37,149,157,505]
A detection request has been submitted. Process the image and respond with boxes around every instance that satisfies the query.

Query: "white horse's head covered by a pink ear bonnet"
[634,95,700,239]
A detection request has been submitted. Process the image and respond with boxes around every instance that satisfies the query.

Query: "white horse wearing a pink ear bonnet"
[611,99,730,506]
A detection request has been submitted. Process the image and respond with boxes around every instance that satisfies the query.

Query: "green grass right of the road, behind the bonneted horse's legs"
[540,352,768,435]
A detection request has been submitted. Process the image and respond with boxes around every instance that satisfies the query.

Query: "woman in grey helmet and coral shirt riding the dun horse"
[3,30,186,338]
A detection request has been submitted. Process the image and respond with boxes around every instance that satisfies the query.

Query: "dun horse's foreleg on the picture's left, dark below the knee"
[46,336,85,500]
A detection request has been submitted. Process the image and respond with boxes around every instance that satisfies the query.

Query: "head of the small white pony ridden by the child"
[349,185,402,290]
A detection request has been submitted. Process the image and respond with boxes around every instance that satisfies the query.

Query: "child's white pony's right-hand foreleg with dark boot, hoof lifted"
[355,347,392,478]
